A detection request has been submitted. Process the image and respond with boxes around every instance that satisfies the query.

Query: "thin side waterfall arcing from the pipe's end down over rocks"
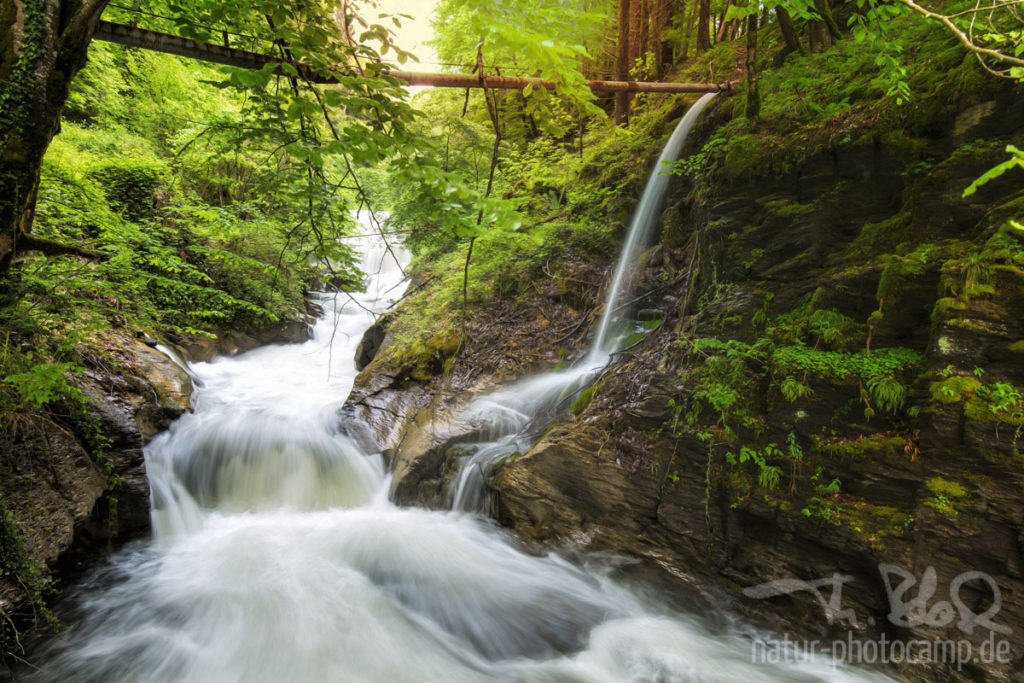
[452,93,715,514]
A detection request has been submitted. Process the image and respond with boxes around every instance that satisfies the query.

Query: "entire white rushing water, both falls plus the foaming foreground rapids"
[29,97,887,683]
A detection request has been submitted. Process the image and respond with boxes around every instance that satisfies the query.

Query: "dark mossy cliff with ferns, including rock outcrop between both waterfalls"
[348,14,1024,680]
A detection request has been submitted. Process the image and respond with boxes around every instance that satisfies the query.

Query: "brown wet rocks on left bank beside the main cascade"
[0,337,193,614]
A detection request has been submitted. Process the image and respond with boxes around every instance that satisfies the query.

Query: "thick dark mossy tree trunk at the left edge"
[0,0,109,278]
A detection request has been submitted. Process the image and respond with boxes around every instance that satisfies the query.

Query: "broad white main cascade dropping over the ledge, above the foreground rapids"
[145,241,409,540]
